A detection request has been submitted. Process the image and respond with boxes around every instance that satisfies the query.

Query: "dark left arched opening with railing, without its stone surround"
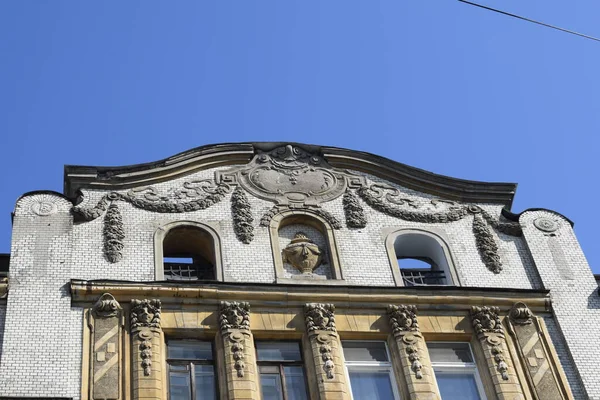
[163,226,216,281]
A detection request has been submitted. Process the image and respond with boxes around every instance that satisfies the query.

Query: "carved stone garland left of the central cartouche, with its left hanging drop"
[71,179,230,263]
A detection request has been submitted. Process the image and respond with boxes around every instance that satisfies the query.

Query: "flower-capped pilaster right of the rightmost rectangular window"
[471,306,525,400]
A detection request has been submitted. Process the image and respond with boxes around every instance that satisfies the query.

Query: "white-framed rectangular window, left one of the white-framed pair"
[342,340,400,400]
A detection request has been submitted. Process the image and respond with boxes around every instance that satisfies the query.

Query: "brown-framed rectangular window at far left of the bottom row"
[167,340,217,400]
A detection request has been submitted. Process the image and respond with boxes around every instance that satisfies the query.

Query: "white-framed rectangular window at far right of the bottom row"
[427,342,485,400]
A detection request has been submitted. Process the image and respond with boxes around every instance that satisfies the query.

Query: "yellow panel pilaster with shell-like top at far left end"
[87,293,124,400]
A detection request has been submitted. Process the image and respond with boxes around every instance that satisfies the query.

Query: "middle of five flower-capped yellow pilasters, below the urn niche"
[304,303,350,400]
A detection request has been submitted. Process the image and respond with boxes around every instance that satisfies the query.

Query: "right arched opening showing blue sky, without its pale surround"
[394,233,452,286]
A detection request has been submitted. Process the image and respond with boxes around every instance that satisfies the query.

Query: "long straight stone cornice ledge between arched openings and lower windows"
[70,279,551,313]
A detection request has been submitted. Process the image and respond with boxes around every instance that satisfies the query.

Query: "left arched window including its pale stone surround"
[155,222,222,281]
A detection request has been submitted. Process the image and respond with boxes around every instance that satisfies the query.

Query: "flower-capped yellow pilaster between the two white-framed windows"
[387,305,440,400]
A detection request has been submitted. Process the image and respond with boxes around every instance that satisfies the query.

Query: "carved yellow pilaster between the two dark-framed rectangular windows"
[217,301,260,400]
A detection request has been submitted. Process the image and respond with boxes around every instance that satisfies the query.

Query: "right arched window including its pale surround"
[386,229,458,286]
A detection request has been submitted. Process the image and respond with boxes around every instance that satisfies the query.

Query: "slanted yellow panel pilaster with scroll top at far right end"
[508,302,573,400]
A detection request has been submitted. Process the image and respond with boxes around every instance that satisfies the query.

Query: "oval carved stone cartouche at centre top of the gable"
[216,144,365,206]
